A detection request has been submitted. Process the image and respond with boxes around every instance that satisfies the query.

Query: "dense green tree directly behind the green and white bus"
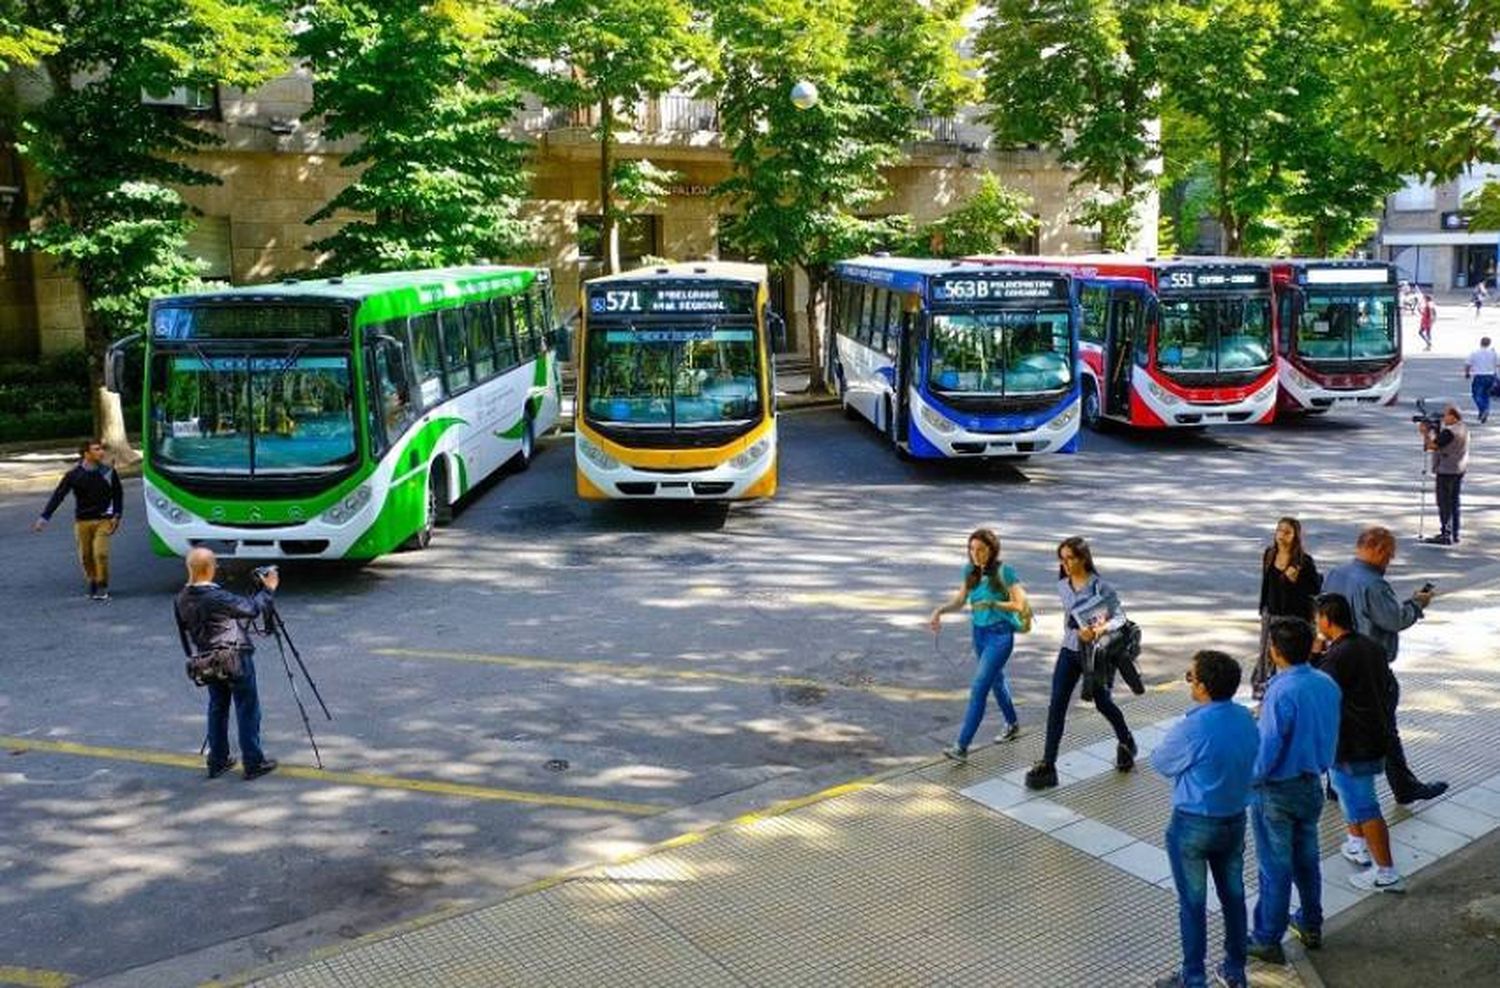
[297,0,530,271]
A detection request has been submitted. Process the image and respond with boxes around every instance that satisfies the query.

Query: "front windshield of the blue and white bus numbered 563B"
[927,310,1073,397]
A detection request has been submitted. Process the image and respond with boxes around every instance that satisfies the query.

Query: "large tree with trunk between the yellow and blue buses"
[711,0,971,390]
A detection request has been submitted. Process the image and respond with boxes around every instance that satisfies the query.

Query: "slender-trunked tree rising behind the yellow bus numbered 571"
[522,0,711,273]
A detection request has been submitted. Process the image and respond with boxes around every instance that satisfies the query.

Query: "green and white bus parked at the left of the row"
[108,265,561,559]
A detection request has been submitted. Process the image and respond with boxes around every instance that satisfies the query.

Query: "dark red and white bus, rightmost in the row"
[1271,259,1401,414]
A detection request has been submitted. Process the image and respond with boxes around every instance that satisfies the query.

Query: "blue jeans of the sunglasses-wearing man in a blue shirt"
[1167,810,1247,988]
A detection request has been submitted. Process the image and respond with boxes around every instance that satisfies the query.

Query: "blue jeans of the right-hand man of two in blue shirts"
[1250,774,1323,943]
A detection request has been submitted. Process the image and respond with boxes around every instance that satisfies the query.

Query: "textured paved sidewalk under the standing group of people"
[222,578,1500,988]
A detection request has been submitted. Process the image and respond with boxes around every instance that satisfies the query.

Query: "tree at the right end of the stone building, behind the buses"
[977,0,1163,249]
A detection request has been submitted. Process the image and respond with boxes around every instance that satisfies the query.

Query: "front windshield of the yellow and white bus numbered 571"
[587,327,761,427]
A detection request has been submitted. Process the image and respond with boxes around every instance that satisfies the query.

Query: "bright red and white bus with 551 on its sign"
[965,255,1277,429]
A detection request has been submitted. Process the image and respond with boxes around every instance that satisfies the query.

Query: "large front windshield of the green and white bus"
[150,352,356,477]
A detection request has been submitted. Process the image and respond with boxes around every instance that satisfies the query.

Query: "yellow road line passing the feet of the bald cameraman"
[0,736,672,817]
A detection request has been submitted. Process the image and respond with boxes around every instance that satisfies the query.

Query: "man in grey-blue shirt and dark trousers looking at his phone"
[1323,525,1448,807]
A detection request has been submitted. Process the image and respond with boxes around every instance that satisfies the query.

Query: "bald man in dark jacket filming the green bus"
[174,546,281,780]
